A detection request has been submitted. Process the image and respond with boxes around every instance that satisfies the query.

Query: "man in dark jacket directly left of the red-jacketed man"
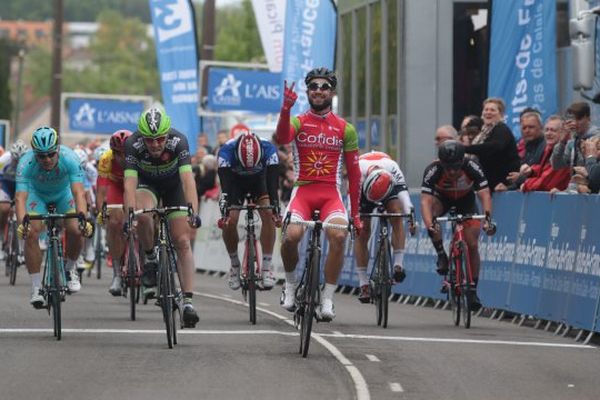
[496,111,548,192]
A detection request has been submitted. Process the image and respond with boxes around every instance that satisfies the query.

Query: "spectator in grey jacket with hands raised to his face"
[552,102,599,172]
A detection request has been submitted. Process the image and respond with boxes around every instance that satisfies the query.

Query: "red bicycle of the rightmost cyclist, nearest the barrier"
[433,207,496,329]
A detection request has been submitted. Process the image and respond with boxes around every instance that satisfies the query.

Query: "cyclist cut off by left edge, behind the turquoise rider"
[0,139,28,260]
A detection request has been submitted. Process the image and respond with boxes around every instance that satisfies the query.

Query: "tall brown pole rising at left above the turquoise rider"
[50,0,63,128]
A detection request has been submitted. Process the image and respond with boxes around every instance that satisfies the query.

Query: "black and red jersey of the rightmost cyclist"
[421,159,488,200]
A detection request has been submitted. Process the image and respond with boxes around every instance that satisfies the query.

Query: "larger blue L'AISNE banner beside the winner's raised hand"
[208,68,282,114]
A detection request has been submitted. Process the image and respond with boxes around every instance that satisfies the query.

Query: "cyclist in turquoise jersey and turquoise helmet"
[15,126,93,308]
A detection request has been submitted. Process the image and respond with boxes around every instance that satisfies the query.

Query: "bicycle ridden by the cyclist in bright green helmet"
[127,204,192,349]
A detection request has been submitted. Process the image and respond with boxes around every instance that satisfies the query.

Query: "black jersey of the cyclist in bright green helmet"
[124,128,192,187]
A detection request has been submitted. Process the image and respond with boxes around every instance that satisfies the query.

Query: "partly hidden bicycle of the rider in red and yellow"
[100,202,142,321]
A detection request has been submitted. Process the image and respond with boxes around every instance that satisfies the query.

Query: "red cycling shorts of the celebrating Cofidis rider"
[286,182,348,222]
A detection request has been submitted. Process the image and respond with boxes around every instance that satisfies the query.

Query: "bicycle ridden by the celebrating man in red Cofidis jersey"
[282,210,354,358]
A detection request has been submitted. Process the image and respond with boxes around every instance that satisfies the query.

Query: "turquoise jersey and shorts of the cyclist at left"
[16,145,83,214]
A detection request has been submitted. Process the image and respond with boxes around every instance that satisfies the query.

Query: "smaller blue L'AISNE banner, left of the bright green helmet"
[66,97,145,135]
